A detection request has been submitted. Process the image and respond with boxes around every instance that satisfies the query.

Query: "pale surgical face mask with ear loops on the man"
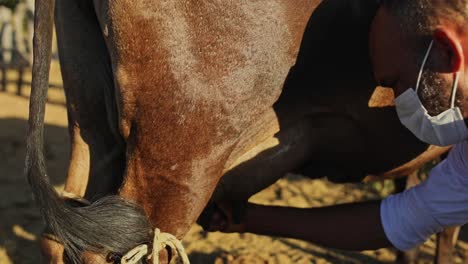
[395,41,468,146]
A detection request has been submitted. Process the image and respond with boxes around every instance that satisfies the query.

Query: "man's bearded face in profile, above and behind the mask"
[369,5,453,115]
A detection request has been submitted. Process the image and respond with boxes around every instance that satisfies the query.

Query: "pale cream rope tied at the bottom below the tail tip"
[121,228,190,264]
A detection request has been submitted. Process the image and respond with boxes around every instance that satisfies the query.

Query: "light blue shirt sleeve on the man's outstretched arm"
[380,142,468,250]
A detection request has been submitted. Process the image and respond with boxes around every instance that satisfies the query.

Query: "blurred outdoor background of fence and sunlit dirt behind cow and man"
[0,0,468,264]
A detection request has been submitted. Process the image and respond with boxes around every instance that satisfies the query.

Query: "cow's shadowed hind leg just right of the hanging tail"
[41,1,125,263]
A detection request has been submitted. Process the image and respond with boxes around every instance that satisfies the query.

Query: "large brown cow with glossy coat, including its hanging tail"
[26,0,450,263]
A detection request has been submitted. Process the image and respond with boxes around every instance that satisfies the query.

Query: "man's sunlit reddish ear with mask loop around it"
[433,27,465,73]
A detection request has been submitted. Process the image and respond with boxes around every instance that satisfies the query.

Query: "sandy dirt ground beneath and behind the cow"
[0,65,468,264]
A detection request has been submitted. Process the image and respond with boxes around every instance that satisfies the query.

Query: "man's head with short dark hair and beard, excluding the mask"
[370,0,468,118]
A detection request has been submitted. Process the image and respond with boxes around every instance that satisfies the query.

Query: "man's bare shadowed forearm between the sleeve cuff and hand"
[244,201,391,250]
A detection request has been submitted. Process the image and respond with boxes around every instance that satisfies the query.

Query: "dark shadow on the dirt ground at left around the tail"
[0,118,69,263]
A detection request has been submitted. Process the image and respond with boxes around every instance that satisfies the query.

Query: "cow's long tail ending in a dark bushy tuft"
[25,0,152,263]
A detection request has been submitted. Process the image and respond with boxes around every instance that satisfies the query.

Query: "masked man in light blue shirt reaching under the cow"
[208,0,468,250]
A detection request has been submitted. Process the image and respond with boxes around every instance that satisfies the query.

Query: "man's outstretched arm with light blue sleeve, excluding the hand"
[245,142,468,250]
